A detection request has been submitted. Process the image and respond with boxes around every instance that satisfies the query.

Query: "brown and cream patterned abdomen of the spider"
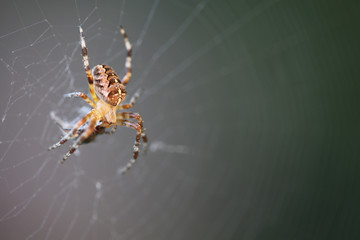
[92,65,126,106]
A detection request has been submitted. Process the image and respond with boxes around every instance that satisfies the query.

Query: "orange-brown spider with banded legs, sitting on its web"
[49,26,147,174]
